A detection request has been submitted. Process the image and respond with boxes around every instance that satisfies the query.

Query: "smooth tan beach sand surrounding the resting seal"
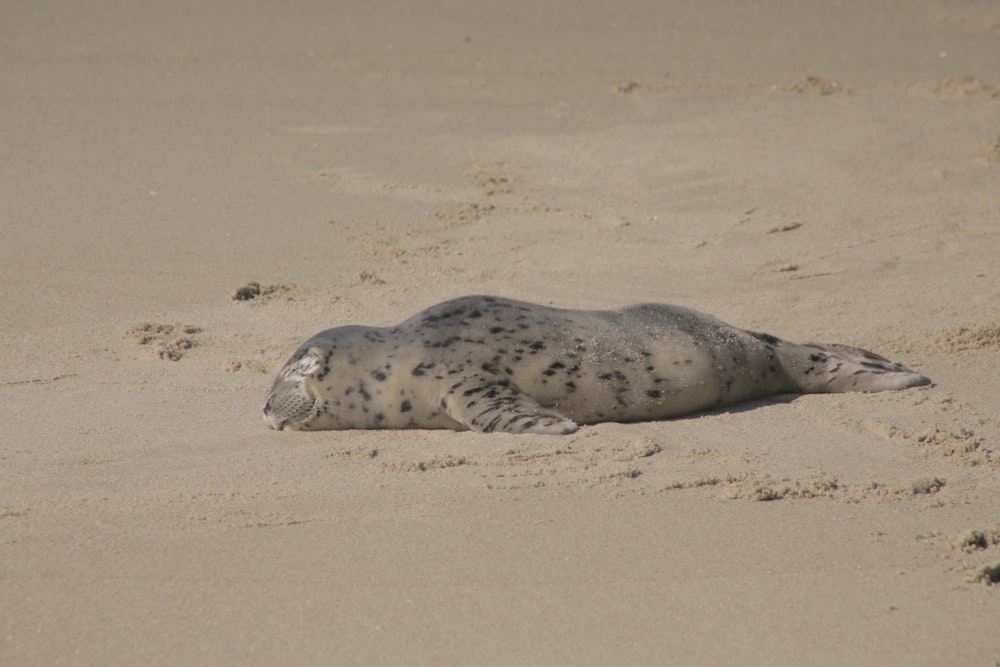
[0,0,1000,666]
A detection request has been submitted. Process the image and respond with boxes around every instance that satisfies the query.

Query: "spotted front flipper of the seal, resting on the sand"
[442,375,579,435]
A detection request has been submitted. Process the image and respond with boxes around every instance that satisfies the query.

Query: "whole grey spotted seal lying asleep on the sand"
[264,296,930,435]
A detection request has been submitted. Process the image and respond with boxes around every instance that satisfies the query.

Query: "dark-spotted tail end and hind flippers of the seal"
[777,341,931,394]
